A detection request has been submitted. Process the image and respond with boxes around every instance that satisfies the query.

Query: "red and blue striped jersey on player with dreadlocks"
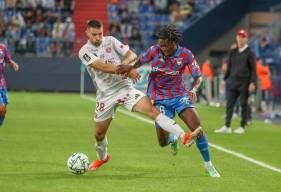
[139,45,201,100]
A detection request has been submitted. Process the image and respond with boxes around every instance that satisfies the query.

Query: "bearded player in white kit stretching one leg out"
[79,20,198,171]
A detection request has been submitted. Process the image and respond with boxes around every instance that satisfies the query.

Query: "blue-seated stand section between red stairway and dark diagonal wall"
[108,0,222,53]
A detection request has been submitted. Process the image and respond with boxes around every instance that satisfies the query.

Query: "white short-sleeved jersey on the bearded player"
[79,36,132,96]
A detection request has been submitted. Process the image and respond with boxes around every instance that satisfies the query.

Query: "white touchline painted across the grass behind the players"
[81,95,281,173]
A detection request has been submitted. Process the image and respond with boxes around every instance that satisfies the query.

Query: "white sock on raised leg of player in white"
[155,113,185,138]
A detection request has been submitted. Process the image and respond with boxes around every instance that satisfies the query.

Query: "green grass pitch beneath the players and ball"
[0,92,281,192]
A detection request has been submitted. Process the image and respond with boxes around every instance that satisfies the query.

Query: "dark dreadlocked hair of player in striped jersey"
[157,25,182,43]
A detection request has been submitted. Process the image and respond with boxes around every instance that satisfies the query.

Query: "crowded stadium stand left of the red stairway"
[0,0,75,56]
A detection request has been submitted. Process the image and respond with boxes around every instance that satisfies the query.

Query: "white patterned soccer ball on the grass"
[67,152,90,175]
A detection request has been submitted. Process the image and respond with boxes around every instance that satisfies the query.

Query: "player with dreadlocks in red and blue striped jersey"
[117,25,220,177]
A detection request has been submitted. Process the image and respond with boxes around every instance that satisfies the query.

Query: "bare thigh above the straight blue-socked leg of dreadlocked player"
[179,108,200,131]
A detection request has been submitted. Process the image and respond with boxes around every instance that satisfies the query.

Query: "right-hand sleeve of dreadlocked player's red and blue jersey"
[185,50,202,77]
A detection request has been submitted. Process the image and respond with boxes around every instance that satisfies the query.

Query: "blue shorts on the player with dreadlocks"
[154,96,194,119]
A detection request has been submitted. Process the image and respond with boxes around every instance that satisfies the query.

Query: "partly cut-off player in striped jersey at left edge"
[0,44,19,127]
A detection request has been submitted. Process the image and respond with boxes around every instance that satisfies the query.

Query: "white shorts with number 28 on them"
[94,87,145,122]
